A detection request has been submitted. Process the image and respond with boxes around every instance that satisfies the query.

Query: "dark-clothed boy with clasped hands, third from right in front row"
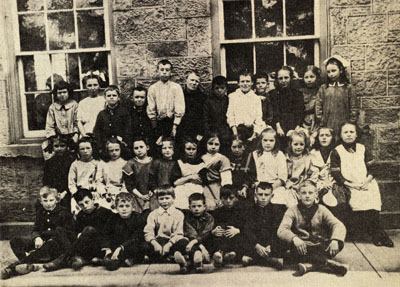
[211,184,245,267]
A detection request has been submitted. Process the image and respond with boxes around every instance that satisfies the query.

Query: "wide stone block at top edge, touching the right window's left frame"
[165,0,210,18]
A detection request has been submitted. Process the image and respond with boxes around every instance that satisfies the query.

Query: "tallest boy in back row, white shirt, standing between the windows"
[147,60,185,142]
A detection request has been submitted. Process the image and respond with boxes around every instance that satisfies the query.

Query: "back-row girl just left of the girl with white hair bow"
[300,66,321,146]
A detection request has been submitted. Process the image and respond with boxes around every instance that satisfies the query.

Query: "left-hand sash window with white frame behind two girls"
[14,0,111,137]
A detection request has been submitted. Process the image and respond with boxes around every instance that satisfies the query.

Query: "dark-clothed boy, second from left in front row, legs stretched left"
[43,189,112,271]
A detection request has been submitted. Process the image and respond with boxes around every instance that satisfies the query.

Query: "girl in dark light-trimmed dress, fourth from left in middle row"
[122,138,156,213]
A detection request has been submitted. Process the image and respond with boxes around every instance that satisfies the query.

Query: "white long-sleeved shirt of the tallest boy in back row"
[147,81,185,125]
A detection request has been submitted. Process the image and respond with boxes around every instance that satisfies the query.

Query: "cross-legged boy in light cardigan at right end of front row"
[278,181,348,276]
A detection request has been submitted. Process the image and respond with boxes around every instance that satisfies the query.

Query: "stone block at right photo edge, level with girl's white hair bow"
[365,44,400,70]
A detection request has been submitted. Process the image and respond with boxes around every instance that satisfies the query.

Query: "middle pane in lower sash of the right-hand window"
[256,42,283,74]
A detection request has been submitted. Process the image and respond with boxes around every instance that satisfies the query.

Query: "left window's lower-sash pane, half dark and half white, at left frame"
[22,55,52,92]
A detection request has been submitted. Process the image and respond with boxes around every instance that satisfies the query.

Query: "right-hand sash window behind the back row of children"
[214,0,324,82]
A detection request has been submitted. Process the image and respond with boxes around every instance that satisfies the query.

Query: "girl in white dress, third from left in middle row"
[100,137,127,213]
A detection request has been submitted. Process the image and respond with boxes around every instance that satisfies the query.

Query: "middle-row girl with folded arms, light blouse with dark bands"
[200,133,232,210]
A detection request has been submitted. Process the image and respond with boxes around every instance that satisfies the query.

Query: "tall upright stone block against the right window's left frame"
[187,18,211,57]
